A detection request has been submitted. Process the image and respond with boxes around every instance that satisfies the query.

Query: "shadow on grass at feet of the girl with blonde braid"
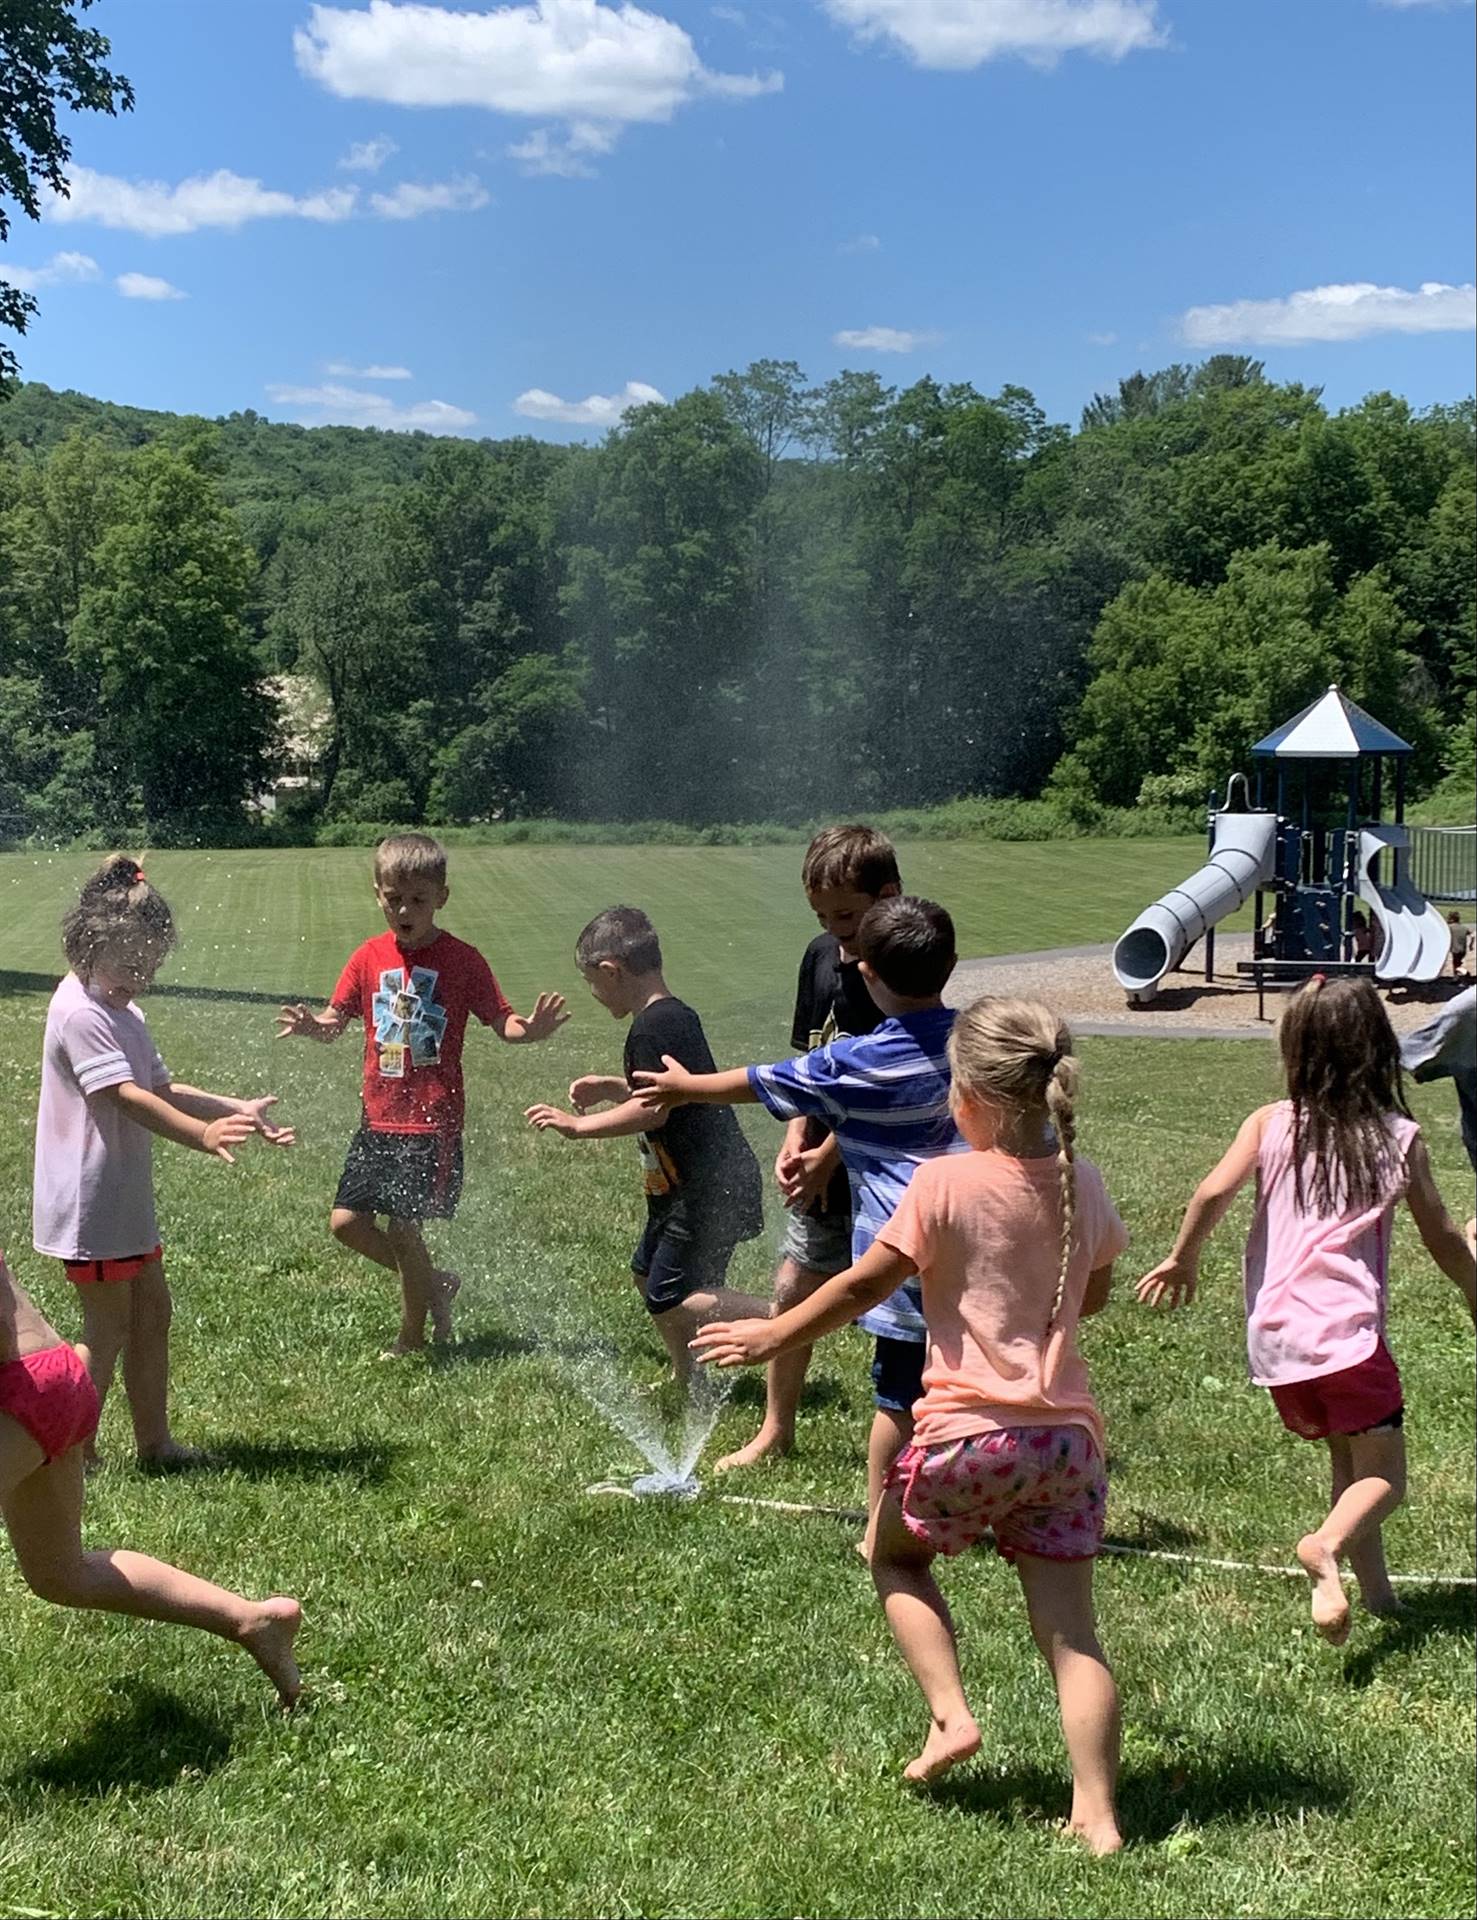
[922,1747,1350,1845]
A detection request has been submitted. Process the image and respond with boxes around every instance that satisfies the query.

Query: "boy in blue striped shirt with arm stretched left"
[634,895,964,1513]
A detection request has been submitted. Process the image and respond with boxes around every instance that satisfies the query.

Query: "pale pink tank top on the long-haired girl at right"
[1245,1100,1419,1386]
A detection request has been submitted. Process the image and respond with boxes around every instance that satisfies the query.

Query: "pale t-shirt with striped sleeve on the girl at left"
[31,973,169,1260]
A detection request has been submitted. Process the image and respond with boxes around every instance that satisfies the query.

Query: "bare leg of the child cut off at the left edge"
[0,1413,302,1707]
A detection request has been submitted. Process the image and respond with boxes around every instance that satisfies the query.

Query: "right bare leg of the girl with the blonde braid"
[1016,1553,1124,1853]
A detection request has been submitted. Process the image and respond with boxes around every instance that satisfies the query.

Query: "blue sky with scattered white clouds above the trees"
[0,0,1473,438]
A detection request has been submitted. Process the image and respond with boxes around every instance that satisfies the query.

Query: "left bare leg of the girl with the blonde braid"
[868,1494,980,1780]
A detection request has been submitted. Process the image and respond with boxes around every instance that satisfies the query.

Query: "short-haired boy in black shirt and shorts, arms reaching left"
[526,906,766,1388]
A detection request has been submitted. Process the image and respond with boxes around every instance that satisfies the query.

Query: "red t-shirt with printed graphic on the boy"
[332,933,513,1133]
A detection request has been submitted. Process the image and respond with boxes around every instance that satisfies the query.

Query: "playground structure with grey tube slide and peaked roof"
[1112,687,1477,1004]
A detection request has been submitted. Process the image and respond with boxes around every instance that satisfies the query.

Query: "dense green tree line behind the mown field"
[0,355,1477,841]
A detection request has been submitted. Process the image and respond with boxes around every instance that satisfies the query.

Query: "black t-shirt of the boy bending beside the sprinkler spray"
[624,995,764,1240]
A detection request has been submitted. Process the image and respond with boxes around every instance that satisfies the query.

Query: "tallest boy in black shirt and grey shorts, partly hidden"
[714,826,903,1473]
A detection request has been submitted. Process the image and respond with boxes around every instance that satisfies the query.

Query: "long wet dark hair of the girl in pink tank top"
[1277,973,1410,1213]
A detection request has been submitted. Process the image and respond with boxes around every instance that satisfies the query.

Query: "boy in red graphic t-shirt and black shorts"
[277,833,569,1359]
